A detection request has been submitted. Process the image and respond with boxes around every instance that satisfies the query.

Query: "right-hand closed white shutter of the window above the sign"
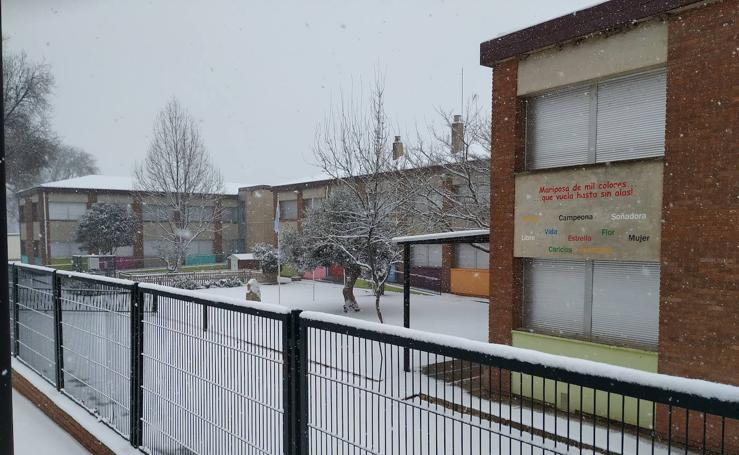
[595,69,667,163]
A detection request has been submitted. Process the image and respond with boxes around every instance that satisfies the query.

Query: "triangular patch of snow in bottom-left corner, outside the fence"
[13,390,88,455]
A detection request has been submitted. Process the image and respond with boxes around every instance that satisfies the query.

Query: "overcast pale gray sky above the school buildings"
[2,0,597,184]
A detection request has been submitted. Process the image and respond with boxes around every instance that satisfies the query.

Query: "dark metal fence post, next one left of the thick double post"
[129,283,144,448]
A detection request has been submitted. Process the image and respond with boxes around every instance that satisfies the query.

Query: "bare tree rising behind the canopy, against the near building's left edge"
[404,97,491,251]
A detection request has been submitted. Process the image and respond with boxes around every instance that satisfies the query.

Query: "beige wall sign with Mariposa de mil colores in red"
[513,161,662,261]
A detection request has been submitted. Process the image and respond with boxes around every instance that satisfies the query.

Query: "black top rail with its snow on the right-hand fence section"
[300,311,739,419]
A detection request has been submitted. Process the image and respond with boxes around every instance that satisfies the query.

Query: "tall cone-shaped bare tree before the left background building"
[135,99,223,271]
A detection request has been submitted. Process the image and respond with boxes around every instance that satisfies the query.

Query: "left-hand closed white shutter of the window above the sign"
[526,86,592,169]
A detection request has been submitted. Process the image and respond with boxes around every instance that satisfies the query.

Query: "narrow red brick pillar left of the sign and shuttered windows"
[488,59,525,344]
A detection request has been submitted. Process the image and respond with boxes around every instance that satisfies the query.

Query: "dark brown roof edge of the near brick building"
[480,0,701,67]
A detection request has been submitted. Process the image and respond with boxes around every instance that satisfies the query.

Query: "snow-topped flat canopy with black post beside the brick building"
[393,229,490,371]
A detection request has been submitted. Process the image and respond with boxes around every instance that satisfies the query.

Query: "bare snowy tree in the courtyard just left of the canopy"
[306,78,420,322]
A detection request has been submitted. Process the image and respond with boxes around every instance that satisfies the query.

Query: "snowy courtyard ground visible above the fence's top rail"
[197,280,488,341]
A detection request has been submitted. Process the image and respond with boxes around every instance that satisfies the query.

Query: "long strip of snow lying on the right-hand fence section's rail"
[300,311,739,403]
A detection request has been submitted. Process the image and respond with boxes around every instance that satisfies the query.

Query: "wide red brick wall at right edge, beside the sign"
[659,0,739,384]
